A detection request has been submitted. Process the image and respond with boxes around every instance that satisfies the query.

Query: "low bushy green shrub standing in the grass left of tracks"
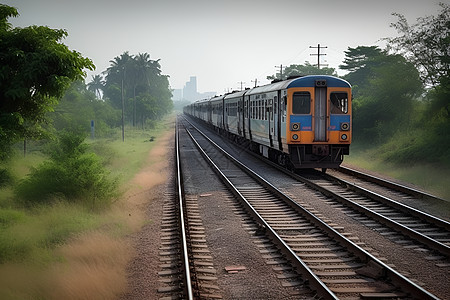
[16,131,117,208]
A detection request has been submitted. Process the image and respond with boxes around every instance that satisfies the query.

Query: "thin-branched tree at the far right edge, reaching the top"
[386,3,450,165]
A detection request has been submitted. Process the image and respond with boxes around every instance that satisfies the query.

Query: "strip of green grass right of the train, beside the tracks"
[344,144,450,200]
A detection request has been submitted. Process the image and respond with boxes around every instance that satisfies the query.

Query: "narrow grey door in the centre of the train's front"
[314,80,327,142]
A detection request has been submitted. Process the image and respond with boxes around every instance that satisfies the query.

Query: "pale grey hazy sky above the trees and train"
[0,0,442,94]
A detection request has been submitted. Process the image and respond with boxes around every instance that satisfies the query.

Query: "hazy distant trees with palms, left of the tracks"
[49,52,173,137]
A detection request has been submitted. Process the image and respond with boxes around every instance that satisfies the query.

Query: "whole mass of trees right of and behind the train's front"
[267,3,450,166]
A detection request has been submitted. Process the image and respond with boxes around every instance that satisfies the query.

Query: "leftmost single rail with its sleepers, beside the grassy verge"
[158,123,222,300]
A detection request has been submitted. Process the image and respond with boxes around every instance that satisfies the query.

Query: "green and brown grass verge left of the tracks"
[0,116,173,299]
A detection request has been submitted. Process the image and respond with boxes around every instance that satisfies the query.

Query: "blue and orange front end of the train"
[285,76,351,169]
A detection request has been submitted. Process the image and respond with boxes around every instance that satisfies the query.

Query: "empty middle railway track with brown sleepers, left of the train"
[180,116,437,299]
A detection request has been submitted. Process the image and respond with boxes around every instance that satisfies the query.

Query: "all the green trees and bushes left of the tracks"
[0,4,173,206]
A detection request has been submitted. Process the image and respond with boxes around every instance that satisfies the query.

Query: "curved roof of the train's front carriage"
[245,75,351,95]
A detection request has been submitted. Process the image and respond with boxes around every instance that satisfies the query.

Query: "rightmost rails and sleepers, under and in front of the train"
[184,116,450,259]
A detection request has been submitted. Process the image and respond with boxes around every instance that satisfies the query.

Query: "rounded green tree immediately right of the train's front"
[341,47,423,143]
